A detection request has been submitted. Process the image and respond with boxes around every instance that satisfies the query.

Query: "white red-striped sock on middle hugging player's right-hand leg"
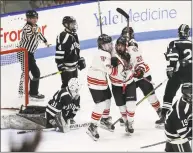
[126,101,136,122]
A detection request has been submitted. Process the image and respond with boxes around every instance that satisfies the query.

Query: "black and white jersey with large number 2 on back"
[165,39,192,68]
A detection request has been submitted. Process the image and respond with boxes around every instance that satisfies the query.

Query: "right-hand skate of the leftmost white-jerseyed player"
[100,116,115,132]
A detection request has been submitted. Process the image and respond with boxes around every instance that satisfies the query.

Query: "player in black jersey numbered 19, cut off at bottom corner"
[165,83,192,152]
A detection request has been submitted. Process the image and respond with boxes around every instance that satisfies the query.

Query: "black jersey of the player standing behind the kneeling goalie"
[55,30,80,68]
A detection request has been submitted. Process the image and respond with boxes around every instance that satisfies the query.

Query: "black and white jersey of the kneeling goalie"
[46,88,79,116]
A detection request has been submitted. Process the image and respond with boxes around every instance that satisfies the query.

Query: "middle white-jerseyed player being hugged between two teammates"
[110,36,145,134]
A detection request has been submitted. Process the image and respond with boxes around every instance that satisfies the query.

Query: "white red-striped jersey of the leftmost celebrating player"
[87,50,115,90]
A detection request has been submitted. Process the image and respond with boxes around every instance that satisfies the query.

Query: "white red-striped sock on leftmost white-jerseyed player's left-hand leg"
[91,101,106,124]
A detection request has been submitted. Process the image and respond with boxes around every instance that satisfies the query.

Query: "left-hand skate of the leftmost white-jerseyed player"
[86,123,99,141]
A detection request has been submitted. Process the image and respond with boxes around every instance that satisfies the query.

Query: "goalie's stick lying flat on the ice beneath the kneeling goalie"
[17,123,90,134]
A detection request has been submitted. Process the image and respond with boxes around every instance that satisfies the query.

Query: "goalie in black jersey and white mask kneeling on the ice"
[46,78,80,132]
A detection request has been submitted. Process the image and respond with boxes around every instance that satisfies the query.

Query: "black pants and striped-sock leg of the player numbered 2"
[162,64,192,116]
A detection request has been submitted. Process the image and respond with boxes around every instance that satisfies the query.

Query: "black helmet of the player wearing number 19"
[181,83,192,104]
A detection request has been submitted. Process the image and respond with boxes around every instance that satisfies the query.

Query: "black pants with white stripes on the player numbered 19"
[165,142,192,152]
